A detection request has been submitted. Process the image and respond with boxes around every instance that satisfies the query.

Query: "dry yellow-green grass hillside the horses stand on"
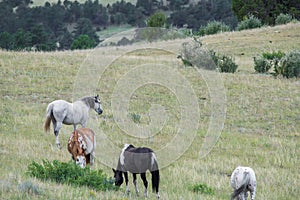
[0,23,300,200]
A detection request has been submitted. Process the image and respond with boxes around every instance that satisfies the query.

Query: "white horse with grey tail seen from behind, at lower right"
[230,166,256,200]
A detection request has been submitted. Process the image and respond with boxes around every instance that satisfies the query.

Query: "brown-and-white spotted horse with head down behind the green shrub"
[68,128,96,168]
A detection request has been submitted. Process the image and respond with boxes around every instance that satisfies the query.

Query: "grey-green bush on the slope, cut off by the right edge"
[278,50,300,78]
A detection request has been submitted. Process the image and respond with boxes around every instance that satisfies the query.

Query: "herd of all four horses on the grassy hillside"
[44,95,256,200]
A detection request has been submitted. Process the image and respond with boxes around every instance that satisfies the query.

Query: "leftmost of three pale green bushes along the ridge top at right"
[198,21,230,36]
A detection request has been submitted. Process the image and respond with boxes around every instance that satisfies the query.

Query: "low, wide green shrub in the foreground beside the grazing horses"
[26,160,116,191]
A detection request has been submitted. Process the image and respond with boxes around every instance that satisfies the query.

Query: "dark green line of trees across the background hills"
[0,0,300,51]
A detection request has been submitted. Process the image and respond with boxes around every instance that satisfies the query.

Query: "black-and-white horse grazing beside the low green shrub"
[112,144,160,199]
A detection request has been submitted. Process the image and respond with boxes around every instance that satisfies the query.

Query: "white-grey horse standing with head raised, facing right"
[44,95,103,147]
